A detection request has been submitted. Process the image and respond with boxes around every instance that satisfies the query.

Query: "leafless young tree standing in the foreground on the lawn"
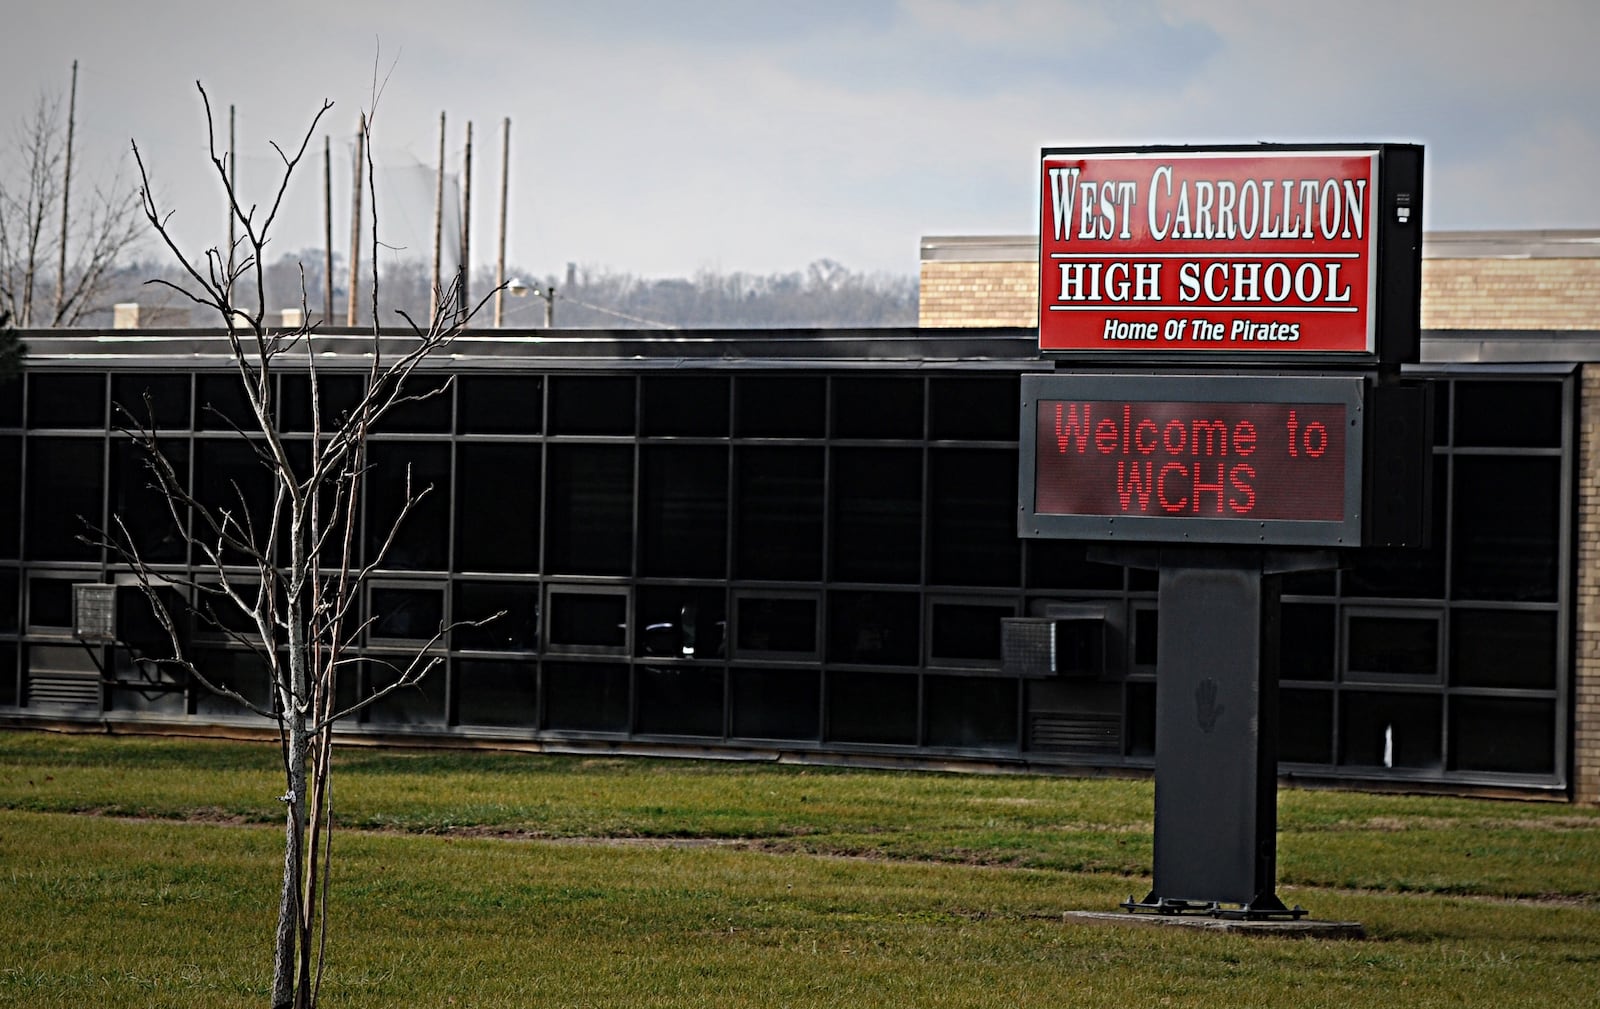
[102,85,498,1007]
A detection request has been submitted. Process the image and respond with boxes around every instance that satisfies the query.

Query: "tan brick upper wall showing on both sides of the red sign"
[918,257,1600,329]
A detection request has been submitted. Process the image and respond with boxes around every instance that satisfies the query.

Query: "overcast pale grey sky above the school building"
[0,0,1600,277]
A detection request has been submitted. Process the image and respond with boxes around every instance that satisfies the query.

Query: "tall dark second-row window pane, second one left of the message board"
[832,448,922,584]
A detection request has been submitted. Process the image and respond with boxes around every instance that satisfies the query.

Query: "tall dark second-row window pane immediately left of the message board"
[928,449,1022,587]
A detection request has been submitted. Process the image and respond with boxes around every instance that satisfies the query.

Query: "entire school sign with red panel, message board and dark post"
[1018,144,1430,918]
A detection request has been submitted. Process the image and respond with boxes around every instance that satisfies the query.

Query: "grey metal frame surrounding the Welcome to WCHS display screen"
[1018,373,1366,547]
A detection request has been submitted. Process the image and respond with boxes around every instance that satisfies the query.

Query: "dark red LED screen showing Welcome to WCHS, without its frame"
[1034,400,1347,523]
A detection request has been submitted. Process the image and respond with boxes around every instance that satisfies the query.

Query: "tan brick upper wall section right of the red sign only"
[1422,259,1600,329]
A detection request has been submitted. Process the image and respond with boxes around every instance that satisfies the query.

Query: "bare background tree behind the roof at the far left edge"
[0,82,142,329]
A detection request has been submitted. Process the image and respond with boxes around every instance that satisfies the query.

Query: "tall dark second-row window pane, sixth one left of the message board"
[456,441,542,572]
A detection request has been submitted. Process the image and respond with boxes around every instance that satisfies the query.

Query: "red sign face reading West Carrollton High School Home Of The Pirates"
[1038,150,1379,355]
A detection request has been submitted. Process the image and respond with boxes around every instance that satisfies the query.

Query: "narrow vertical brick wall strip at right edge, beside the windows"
[1573,365,1600,803]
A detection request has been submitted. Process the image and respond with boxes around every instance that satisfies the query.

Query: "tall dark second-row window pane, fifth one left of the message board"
[544,445,634,574]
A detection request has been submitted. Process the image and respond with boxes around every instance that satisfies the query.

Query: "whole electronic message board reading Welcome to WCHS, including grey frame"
[1018,374,1366,547]
